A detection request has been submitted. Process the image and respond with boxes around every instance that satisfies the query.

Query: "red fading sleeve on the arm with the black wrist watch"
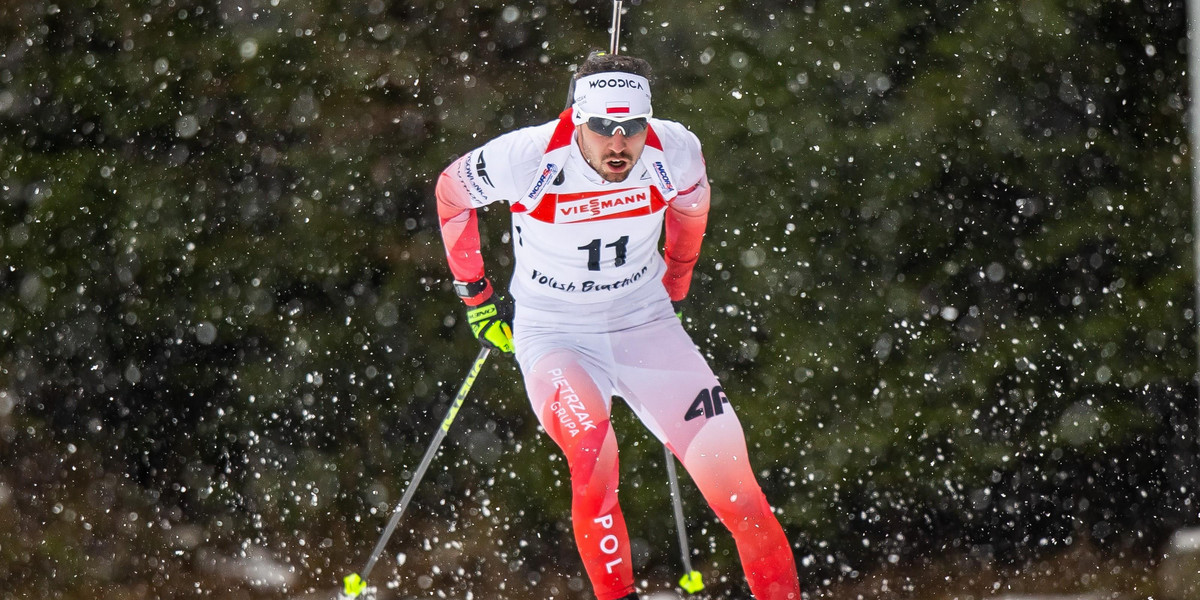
[433,158,492,306]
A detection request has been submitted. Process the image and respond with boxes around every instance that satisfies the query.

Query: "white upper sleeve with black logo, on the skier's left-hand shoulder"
[450,124,553,208]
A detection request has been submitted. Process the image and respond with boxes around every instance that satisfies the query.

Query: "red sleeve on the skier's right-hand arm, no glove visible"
[662,178,710,301]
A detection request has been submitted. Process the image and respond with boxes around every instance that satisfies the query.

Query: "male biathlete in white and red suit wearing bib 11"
[436,54,800,600]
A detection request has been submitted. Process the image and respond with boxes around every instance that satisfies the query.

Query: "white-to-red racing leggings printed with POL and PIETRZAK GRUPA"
[522,319,800,600]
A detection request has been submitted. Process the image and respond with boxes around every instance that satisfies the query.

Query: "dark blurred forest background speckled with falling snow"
[0,0,1200,599]
